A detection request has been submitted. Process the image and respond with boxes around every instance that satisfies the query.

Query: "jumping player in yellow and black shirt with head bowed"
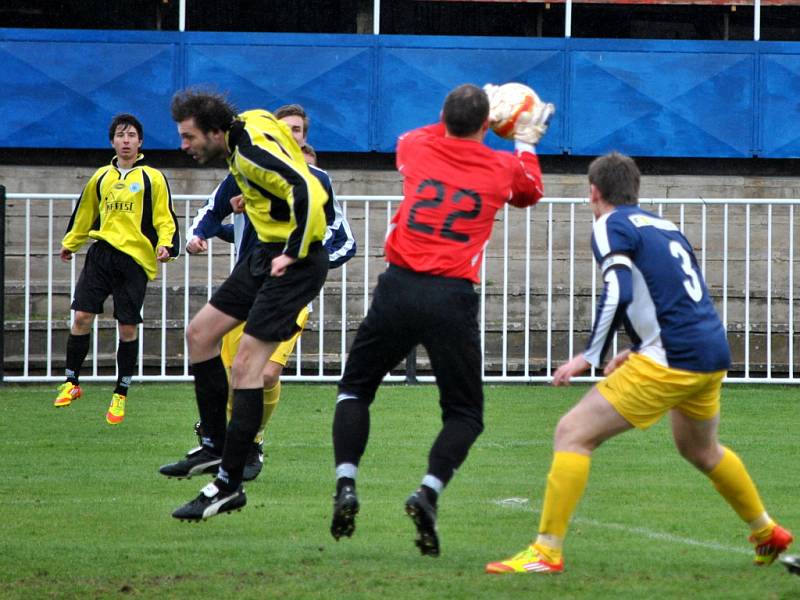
[166,90,328,520]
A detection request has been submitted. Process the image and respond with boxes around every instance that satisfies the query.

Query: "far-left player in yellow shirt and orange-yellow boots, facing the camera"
[54,114,180,425]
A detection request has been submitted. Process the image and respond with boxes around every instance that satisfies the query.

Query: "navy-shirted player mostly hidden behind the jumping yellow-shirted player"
[159,104,356,481]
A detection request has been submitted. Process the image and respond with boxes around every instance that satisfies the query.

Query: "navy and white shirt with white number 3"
[584,206,730,372]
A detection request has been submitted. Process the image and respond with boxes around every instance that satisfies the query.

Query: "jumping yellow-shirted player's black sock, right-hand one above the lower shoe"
[217,388,264,492]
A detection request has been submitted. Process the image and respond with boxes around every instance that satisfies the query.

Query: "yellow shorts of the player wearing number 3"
[597,353,726,429]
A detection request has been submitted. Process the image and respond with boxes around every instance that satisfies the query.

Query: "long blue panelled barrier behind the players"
[0,29,800,158]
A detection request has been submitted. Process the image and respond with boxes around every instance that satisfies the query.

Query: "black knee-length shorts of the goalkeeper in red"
[339,265,483,423]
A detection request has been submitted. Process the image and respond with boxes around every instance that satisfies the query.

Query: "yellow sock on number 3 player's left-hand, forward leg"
[536,452,592,540]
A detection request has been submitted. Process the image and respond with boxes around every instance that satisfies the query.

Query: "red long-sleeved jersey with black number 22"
[386,123,543,283]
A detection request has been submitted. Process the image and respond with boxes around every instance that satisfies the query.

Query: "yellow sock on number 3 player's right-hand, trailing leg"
[708,447,775,536]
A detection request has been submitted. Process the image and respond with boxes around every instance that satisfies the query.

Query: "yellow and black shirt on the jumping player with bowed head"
[227,110,328,259]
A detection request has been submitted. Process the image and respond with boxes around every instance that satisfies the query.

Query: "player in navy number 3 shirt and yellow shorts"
[486,153,793,573]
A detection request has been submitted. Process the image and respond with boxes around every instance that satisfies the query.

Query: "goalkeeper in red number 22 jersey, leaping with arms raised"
[331,84,546,556]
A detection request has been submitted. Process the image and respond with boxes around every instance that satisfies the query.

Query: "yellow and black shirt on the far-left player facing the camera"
[61,154,180,280]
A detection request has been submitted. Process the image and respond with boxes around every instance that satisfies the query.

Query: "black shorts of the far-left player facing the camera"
[72,240,147,325]
